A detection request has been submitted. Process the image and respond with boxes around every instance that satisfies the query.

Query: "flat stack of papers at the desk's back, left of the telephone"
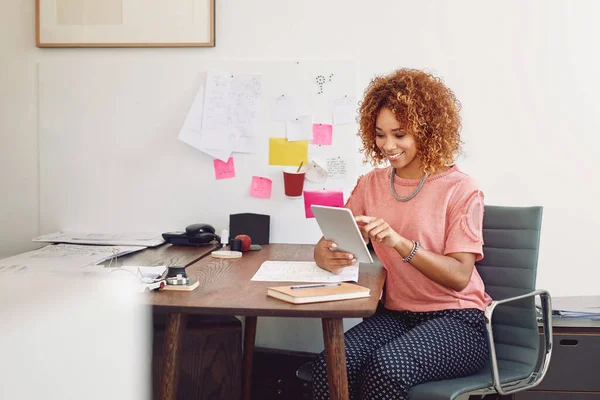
[32,231,165,247]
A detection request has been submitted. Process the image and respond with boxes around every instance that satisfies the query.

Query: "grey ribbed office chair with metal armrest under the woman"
[296,206,552,400]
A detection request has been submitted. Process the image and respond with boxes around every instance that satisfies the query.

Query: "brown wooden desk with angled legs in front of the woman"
[150,244,385,400]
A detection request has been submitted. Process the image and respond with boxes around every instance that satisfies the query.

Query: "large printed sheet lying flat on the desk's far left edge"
[0,244,145,272]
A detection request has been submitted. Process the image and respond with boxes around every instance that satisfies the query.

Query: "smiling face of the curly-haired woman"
[375,107,423,179]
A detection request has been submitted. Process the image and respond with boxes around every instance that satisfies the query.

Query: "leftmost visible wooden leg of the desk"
[160,313,187,400]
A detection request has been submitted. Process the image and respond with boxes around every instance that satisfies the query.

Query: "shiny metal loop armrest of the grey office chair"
[485,289,552,396]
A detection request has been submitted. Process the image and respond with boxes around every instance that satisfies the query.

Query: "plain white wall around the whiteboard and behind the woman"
[0,0,600,350]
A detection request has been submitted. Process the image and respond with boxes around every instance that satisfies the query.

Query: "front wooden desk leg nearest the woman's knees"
[323,318,348,400]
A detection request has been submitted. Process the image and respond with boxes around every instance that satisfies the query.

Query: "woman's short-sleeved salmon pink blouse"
[346,165,492,312]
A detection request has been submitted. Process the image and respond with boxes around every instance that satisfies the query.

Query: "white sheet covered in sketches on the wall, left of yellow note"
[200,71,262,158]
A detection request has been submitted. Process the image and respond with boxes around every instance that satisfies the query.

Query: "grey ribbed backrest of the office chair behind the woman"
[476,206,542,376]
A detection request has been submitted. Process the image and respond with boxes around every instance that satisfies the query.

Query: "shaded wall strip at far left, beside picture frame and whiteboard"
[0,0,39,257]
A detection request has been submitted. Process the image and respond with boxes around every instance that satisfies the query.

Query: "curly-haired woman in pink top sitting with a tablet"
[313,69,491,400]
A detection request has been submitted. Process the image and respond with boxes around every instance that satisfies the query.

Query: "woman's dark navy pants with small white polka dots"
[312,307,488,400]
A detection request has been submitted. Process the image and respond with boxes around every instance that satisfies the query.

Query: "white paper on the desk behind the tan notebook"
[251,261,358,282]
